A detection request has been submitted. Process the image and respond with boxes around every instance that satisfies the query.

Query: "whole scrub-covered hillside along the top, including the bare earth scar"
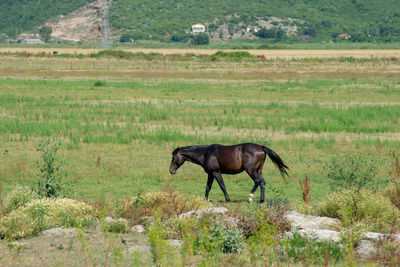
[0,0,400,42]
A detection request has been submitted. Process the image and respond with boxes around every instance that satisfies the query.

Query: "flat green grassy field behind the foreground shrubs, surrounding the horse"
[0,49,400,205]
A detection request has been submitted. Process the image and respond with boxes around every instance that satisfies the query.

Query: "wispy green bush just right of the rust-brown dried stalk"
[326,155,378,189]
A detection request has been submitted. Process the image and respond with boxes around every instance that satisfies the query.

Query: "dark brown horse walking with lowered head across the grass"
[169,143,289,203]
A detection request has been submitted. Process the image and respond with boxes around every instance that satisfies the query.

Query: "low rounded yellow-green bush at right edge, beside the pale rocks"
[318,189,400,232]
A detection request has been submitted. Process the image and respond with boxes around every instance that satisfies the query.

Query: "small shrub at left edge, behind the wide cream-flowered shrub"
[3,184,37,213]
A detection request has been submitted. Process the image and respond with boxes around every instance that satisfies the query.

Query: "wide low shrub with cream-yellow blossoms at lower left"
[0,198,95,239]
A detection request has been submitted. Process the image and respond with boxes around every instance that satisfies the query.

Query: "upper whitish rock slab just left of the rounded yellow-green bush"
[285,211,340,230]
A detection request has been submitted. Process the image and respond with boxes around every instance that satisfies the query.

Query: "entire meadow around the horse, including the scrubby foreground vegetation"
[0,48,400,266]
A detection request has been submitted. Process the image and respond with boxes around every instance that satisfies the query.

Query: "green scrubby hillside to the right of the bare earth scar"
[110,0,400,41]
